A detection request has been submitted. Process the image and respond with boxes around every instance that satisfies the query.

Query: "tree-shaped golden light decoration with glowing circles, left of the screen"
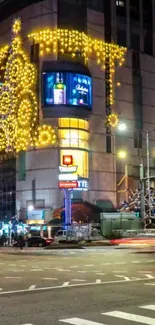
[0,19,57,152]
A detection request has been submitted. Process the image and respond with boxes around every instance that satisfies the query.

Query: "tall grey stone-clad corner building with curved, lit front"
[0,0,155,219]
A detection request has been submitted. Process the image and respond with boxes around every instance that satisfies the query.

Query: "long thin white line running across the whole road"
[0,277,155,295]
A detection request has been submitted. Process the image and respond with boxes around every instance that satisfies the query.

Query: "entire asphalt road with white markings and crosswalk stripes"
[0,246,155,325]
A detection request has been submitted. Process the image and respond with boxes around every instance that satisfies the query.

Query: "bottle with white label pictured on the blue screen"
[53,73,66,105]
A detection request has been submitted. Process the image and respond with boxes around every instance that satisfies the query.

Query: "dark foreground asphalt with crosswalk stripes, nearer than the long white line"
[0,274,155,325]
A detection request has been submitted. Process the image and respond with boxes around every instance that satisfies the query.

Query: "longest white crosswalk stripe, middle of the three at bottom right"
[102,310,155,325]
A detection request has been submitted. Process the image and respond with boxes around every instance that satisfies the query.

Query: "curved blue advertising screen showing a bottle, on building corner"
[43,72,92,109]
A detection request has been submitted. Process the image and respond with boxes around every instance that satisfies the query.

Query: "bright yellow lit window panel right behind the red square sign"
[60,150,89,178]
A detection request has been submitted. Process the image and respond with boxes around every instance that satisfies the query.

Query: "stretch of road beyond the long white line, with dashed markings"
[0,250,155,295]
